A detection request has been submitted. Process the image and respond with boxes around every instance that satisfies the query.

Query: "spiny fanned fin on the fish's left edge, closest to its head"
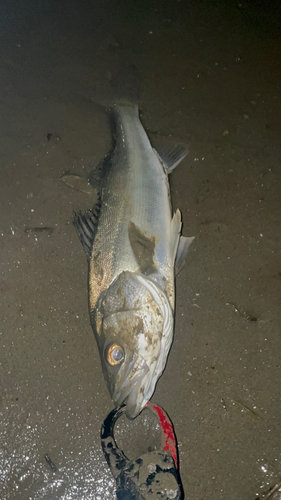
[73,201,101,261]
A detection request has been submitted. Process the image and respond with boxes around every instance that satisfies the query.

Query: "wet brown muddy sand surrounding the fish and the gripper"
[0,0,281,500]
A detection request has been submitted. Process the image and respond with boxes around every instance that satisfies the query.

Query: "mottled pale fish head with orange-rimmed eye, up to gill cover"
[94,271,173,419]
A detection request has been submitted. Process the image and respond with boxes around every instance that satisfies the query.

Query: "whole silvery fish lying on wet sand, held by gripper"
[73,99,193,419]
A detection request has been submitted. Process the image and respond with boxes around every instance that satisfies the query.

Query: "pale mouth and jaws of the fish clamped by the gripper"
[112,355,151,420]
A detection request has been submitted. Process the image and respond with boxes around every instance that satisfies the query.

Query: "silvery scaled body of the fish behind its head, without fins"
[90,102,173,307]
